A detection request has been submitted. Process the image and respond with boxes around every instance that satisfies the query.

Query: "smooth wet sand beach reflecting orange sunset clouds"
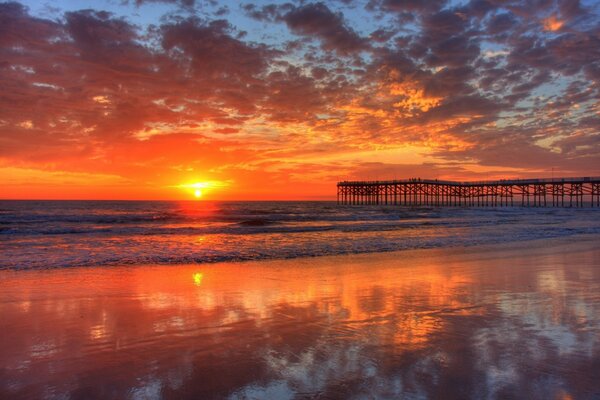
[0,236,600,399]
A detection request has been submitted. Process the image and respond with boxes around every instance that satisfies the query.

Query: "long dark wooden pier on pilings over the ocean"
[337,177,600,207]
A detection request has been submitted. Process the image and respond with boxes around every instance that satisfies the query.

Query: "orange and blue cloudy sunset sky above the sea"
[0,0,600,200]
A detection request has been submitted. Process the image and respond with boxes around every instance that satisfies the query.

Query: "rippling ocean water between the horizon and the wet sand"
[0,201,600,269]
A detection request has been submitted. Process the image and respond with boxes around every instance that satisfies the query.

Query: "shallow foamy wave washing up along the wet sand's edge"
[0,223,600,270]
